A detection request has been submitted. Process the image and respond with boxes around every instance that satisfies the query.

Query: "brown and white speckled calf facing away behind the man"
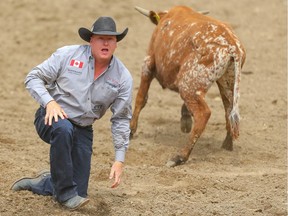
[130,6,245,166]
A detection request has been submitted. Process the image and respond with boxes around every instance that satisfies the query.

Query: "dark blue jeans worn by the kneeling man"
[32,107,93,202]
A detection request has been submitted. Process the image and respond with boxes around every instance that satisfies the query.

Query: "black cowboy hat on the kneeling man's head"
[78,17,128,42]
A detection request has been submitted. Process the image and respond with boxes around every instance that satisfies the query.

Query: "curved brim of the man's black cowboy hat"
[78,27,128,42]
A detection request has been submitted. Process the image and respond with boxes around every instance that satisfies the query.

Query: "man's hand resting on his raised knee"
[45,100,68,126]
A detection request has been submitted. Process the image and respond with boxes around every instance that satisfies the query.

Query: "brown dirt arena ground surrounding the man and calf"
[0,0,287,216]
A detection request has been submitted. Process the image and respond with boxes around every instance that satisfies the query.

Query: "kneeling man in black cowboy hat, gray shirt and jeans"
[11,17,133,210]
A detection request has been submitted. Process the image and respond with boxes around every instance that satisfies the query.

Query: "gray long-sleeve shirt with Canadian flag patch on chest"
[25,45,133,162]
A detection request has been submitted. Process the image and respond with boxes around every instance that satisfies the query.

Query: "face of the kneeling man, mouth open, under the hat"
[90,35,117,61]
